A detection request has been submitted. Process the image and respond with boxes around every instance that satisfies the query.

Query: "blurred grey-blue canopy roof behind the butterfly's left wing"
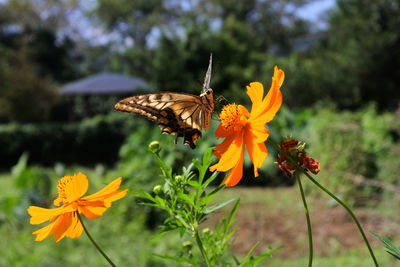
[61,72,149,95]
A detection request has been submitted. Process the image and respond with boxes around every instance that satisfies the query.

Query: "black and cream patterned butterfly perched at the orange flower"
[114,55,214,149]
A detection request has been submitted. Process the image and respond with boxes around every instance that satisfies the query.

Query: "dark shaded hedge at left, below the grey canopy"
[0,113,146,168]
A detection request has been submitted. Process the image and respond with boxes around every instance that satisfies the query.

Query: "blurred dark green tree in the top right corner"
[304,0,400,109]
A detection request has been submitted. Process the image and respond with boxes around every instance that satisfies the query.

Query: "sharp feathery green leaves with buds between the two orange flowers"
[136,144,272,266]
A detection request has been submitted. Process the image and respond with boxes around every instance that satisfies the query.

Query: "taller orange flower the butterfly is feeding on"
[210,67,285,186]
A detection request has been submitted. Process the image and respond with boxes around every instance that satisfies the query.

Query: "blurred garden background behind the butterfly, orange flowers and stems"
[0,0,400,266]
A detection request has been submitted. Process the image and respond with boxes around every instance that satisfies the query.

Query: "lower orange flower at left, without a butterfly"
[28,173,127,242]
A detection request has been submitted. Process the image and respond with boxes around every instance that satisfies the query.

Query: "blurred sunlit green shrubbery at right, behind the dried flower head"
[271,105,400,204]
